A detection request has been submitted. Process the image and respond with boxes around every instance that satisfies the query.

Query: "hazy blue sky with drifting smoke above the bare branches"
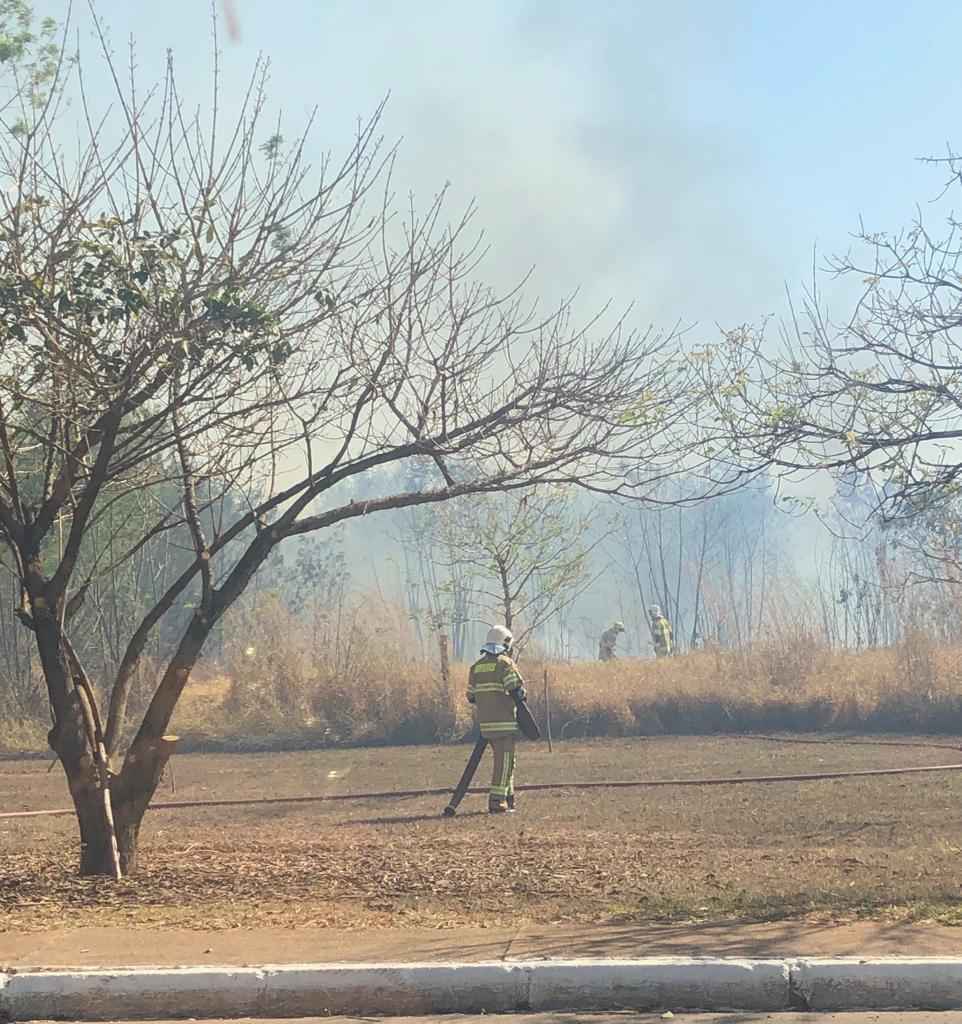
[64,0,962,348]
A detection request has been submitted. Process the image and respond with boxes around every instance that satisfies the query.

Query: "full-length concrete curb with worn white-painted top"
[0,956,962,1021]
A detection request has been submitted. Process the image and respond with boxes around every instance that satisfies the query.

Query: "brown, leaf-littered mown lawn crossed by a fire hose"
[0,737,962,930]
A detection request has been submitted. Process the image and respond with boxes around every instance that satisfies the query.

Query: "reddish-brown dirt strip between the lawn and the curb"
[0,920,962,971]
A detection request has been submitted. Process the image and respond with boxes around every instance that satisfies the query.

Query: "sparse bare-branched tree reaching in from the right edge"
[700,153,962,536]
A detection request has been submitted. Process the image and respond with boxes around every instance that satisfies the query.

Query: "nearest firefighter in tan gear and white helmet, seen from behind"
[467,626,526,814]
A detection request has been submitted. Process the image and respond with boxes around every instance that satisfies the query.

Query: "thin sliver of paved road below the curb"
[36,1011,962,1024]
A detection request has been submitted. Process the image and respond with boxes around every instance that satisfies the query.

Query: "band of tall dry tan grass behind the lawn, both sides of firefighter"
[9,614,962,752]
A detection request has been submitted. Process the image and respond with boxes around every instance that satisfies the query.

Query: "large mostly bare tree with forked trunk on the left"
[0,18,733,874]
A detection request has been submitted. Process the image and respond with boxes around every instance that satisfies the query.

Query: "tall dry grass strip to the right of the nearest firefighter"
[530,636,962,736]
